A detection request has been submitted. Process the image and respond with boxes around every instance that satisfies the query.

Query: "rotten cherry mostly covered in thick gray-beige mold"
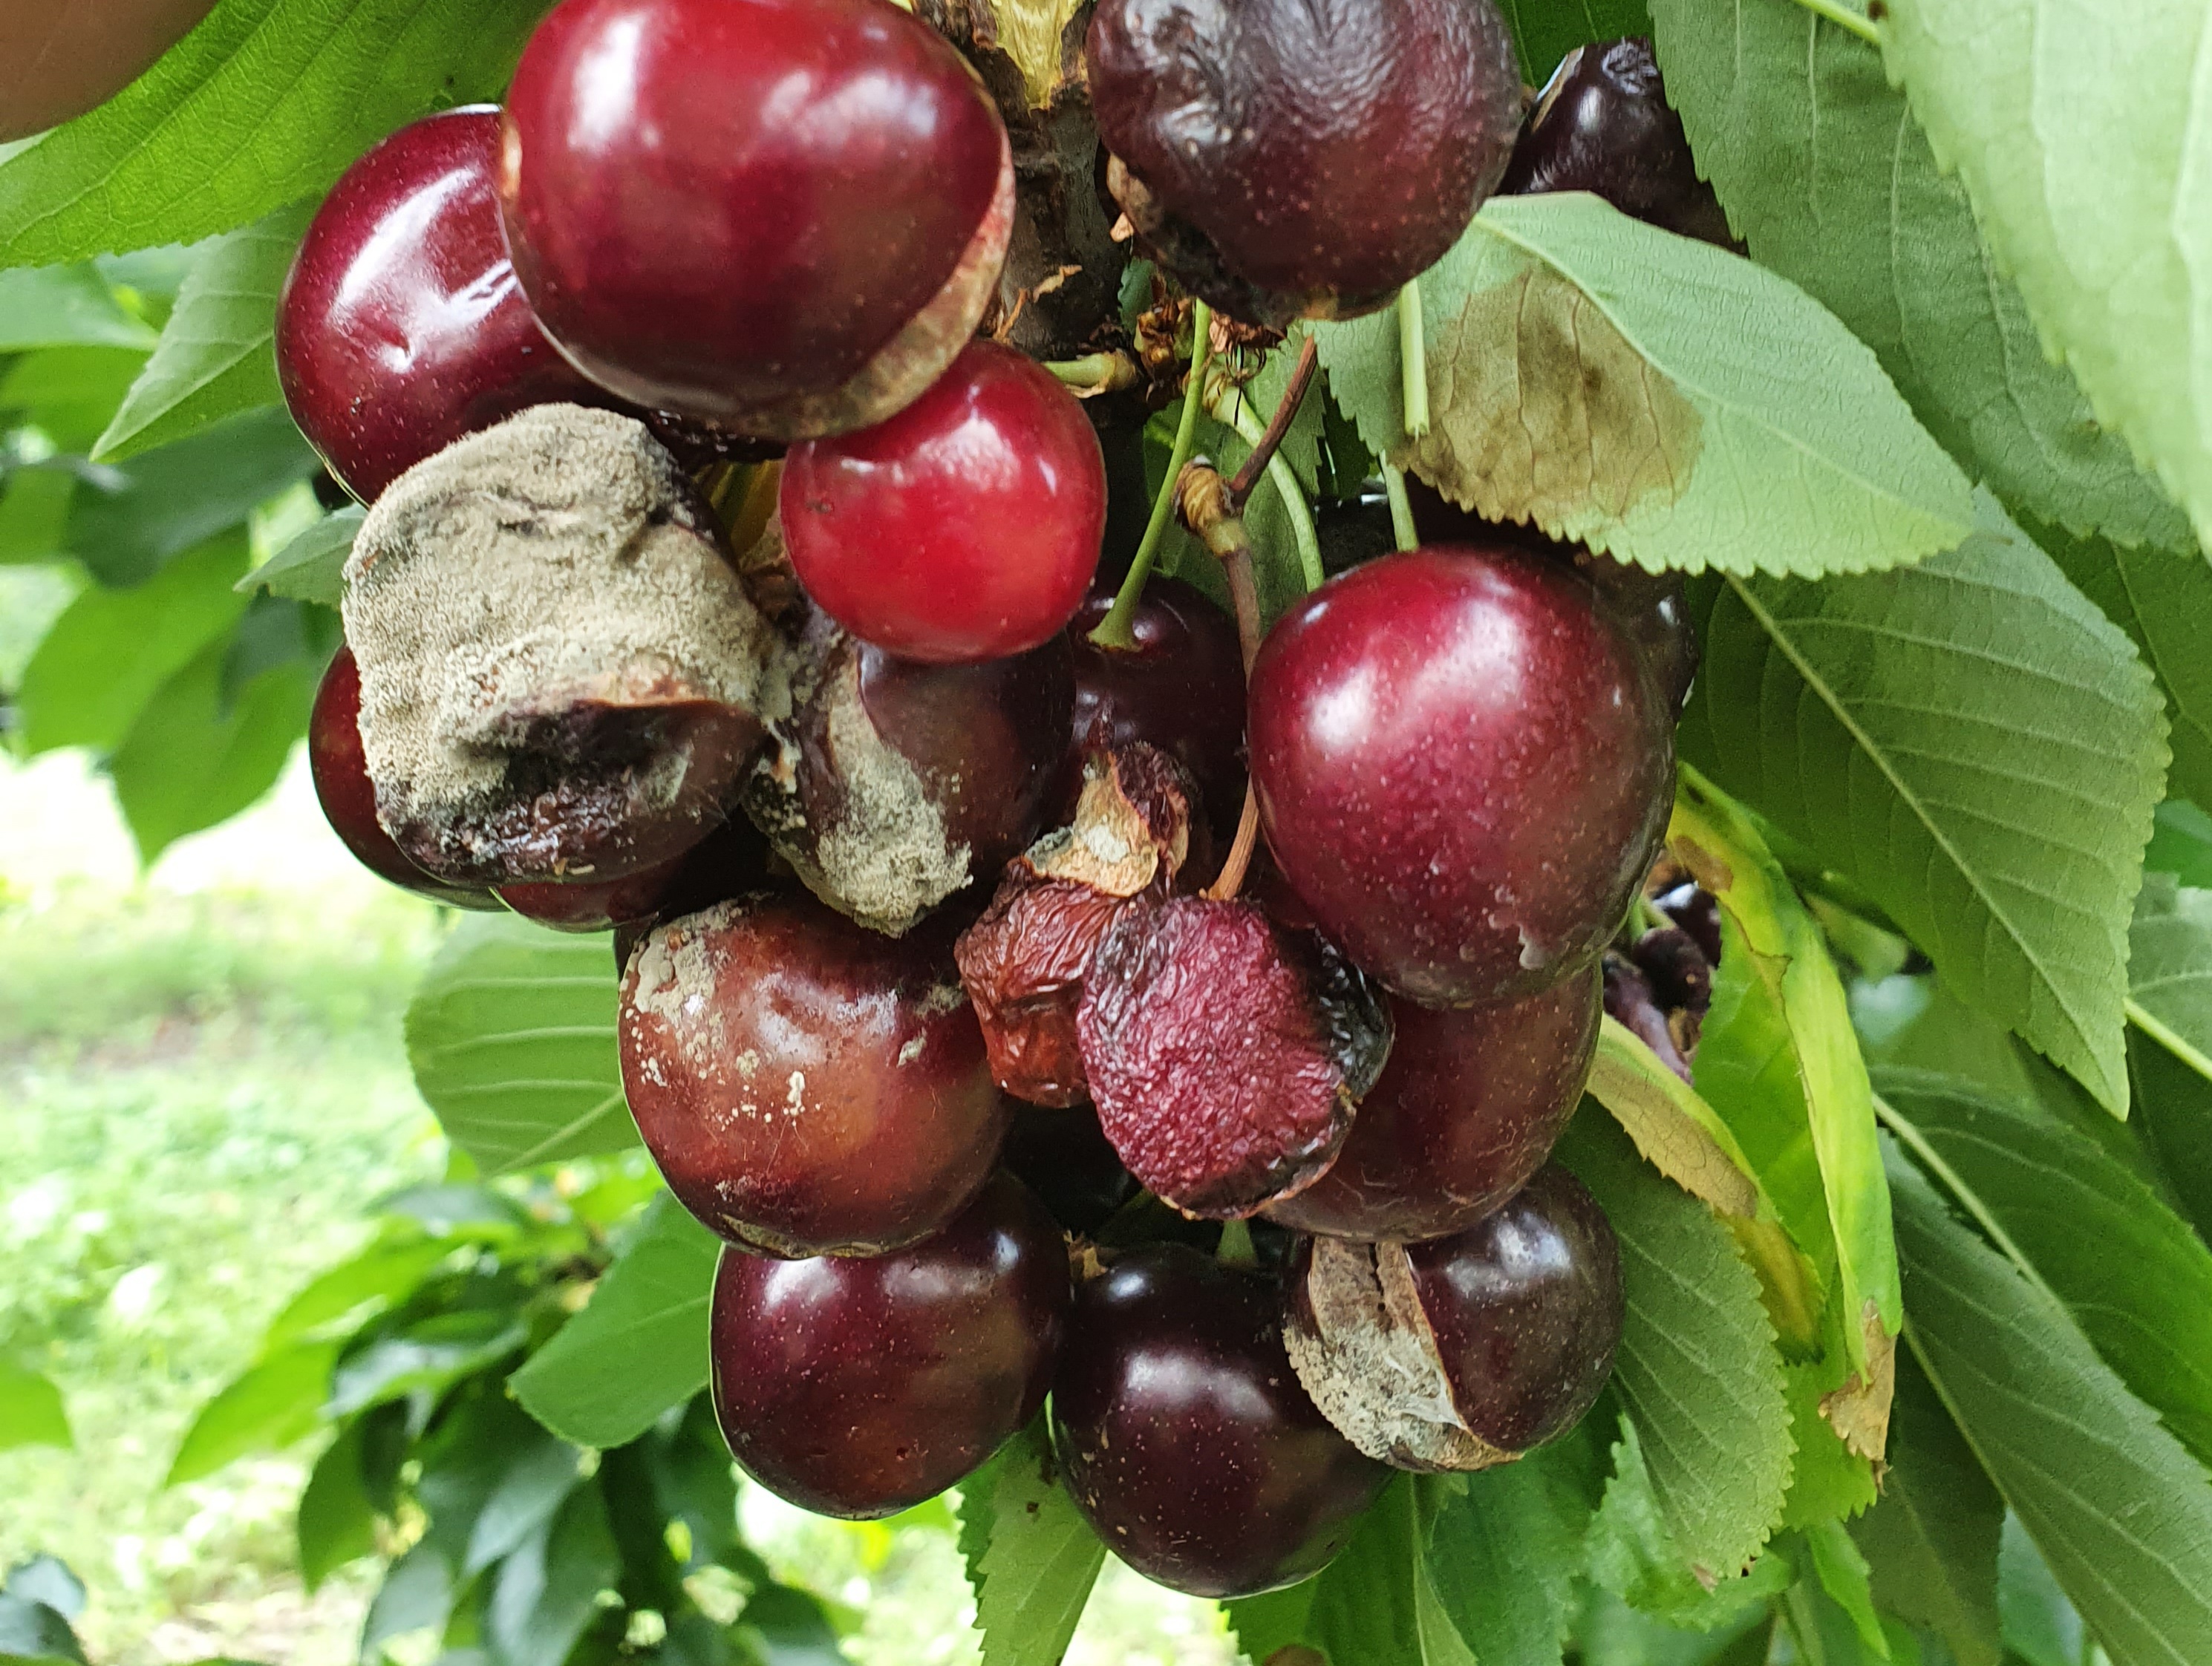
[345,405,788,885]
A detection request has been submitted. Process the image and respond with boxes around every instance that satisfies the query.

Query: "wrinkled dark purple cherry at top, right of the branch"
[1089,0,1522,327]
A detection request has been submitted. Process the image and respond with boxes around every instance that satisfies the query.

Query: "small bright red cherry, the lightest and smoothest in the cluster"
[781,341,1106,664]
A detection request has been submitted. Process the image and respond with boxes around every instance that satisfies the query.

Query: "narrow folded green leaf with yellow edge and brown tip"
[1668,768,1902,1389]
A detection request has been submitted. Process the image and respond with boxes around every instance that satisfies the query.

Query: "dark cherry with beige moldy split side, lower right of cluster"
[1283,1164,1624,1469]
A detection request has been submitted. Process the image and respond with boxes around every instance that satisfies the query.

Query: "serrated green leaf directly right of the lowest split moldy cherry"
[1559,1117,1789,1580]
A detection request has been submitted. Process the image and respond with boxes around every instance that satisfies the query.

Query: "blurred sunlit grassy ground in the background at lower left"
[0,754,1236,1666]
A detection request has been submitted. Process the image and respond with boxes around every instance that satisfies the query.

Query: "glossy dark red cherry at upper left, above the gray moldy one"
[276,106,606,502]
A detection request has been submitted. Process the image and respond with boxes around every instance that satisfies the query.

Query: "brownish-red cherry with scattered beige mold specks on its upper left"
[619,894,1006,1257]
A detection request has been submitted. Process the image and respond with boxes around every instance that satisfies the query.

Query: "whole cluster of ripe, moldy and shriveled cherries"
[290,0,1710,1595]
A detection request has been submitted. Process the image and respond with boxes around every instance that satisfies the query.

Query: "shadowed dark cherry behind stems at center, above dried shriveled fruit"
[1057,578,1245,836]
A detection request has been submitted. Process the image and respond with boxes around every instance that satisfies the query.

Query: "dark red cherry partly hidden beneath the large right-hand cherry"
[1268,971,1599,1241]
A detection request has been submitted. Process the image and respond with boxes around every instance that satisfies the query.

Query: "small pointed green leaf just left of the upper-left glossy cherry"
[93,203,312,463]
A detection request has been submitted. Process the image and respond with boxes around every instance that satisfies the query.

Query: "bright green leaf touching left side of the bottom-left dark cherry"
[509,1192,721,1447]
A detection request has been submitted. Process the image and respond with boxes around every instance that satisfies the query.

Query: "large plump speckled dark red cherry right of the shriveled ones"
[1250,546,1674,1004]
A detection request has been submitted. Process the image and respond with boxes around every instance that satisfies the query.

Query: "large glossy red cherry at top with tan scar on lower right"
[500,0,1013,440]
